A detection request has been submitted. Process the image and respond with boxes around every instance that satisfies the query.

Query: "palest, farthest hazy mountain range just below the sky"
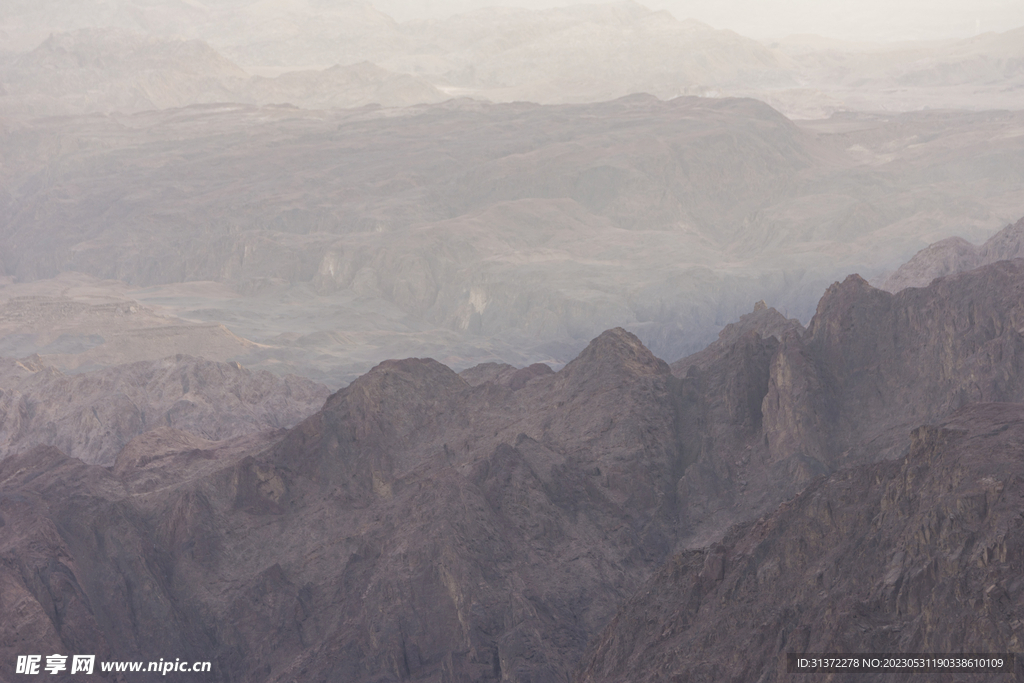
[0,0,1024,118]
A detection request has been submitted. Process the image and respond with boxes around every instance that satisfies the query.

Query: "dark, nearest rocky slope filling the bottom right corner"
[577,403,1024,683]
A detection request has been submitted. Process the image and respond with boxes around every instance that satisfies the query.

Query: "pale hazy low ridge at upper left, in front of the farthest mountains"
[0,29,447,116]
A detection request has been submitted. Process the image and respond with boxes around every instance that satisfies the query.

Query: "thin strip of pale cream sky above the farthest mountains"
[372,0,1024,41]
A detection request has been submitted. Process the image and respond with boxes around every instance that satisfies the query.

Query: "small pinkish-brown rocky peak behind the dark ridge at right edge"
[879,218,1024,293]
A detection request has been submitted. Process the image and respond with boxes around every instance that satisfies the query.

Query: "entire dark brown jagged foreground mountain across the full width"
[6,254,1024,682]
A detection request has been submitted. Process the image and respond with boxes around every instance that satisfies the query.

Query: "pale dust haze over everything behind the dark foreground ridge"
[0,0,1024,387]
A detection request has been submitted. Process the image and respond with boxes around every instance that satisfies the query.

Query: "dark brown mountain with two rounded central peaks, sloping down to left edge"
[0,330,685,681]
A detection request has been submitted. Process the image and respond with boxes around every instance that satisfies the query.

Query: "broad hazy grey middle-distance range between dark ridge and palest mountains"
[0,96,1024,388]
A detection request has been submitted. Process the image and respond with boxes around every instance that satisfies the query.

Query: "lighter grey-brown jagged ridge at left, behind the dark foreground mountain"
[0,355,330,465]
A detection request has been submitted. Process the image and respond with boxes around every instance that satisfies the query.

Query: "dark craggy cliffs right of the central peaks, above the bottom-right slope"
[673,259,1024,540]
